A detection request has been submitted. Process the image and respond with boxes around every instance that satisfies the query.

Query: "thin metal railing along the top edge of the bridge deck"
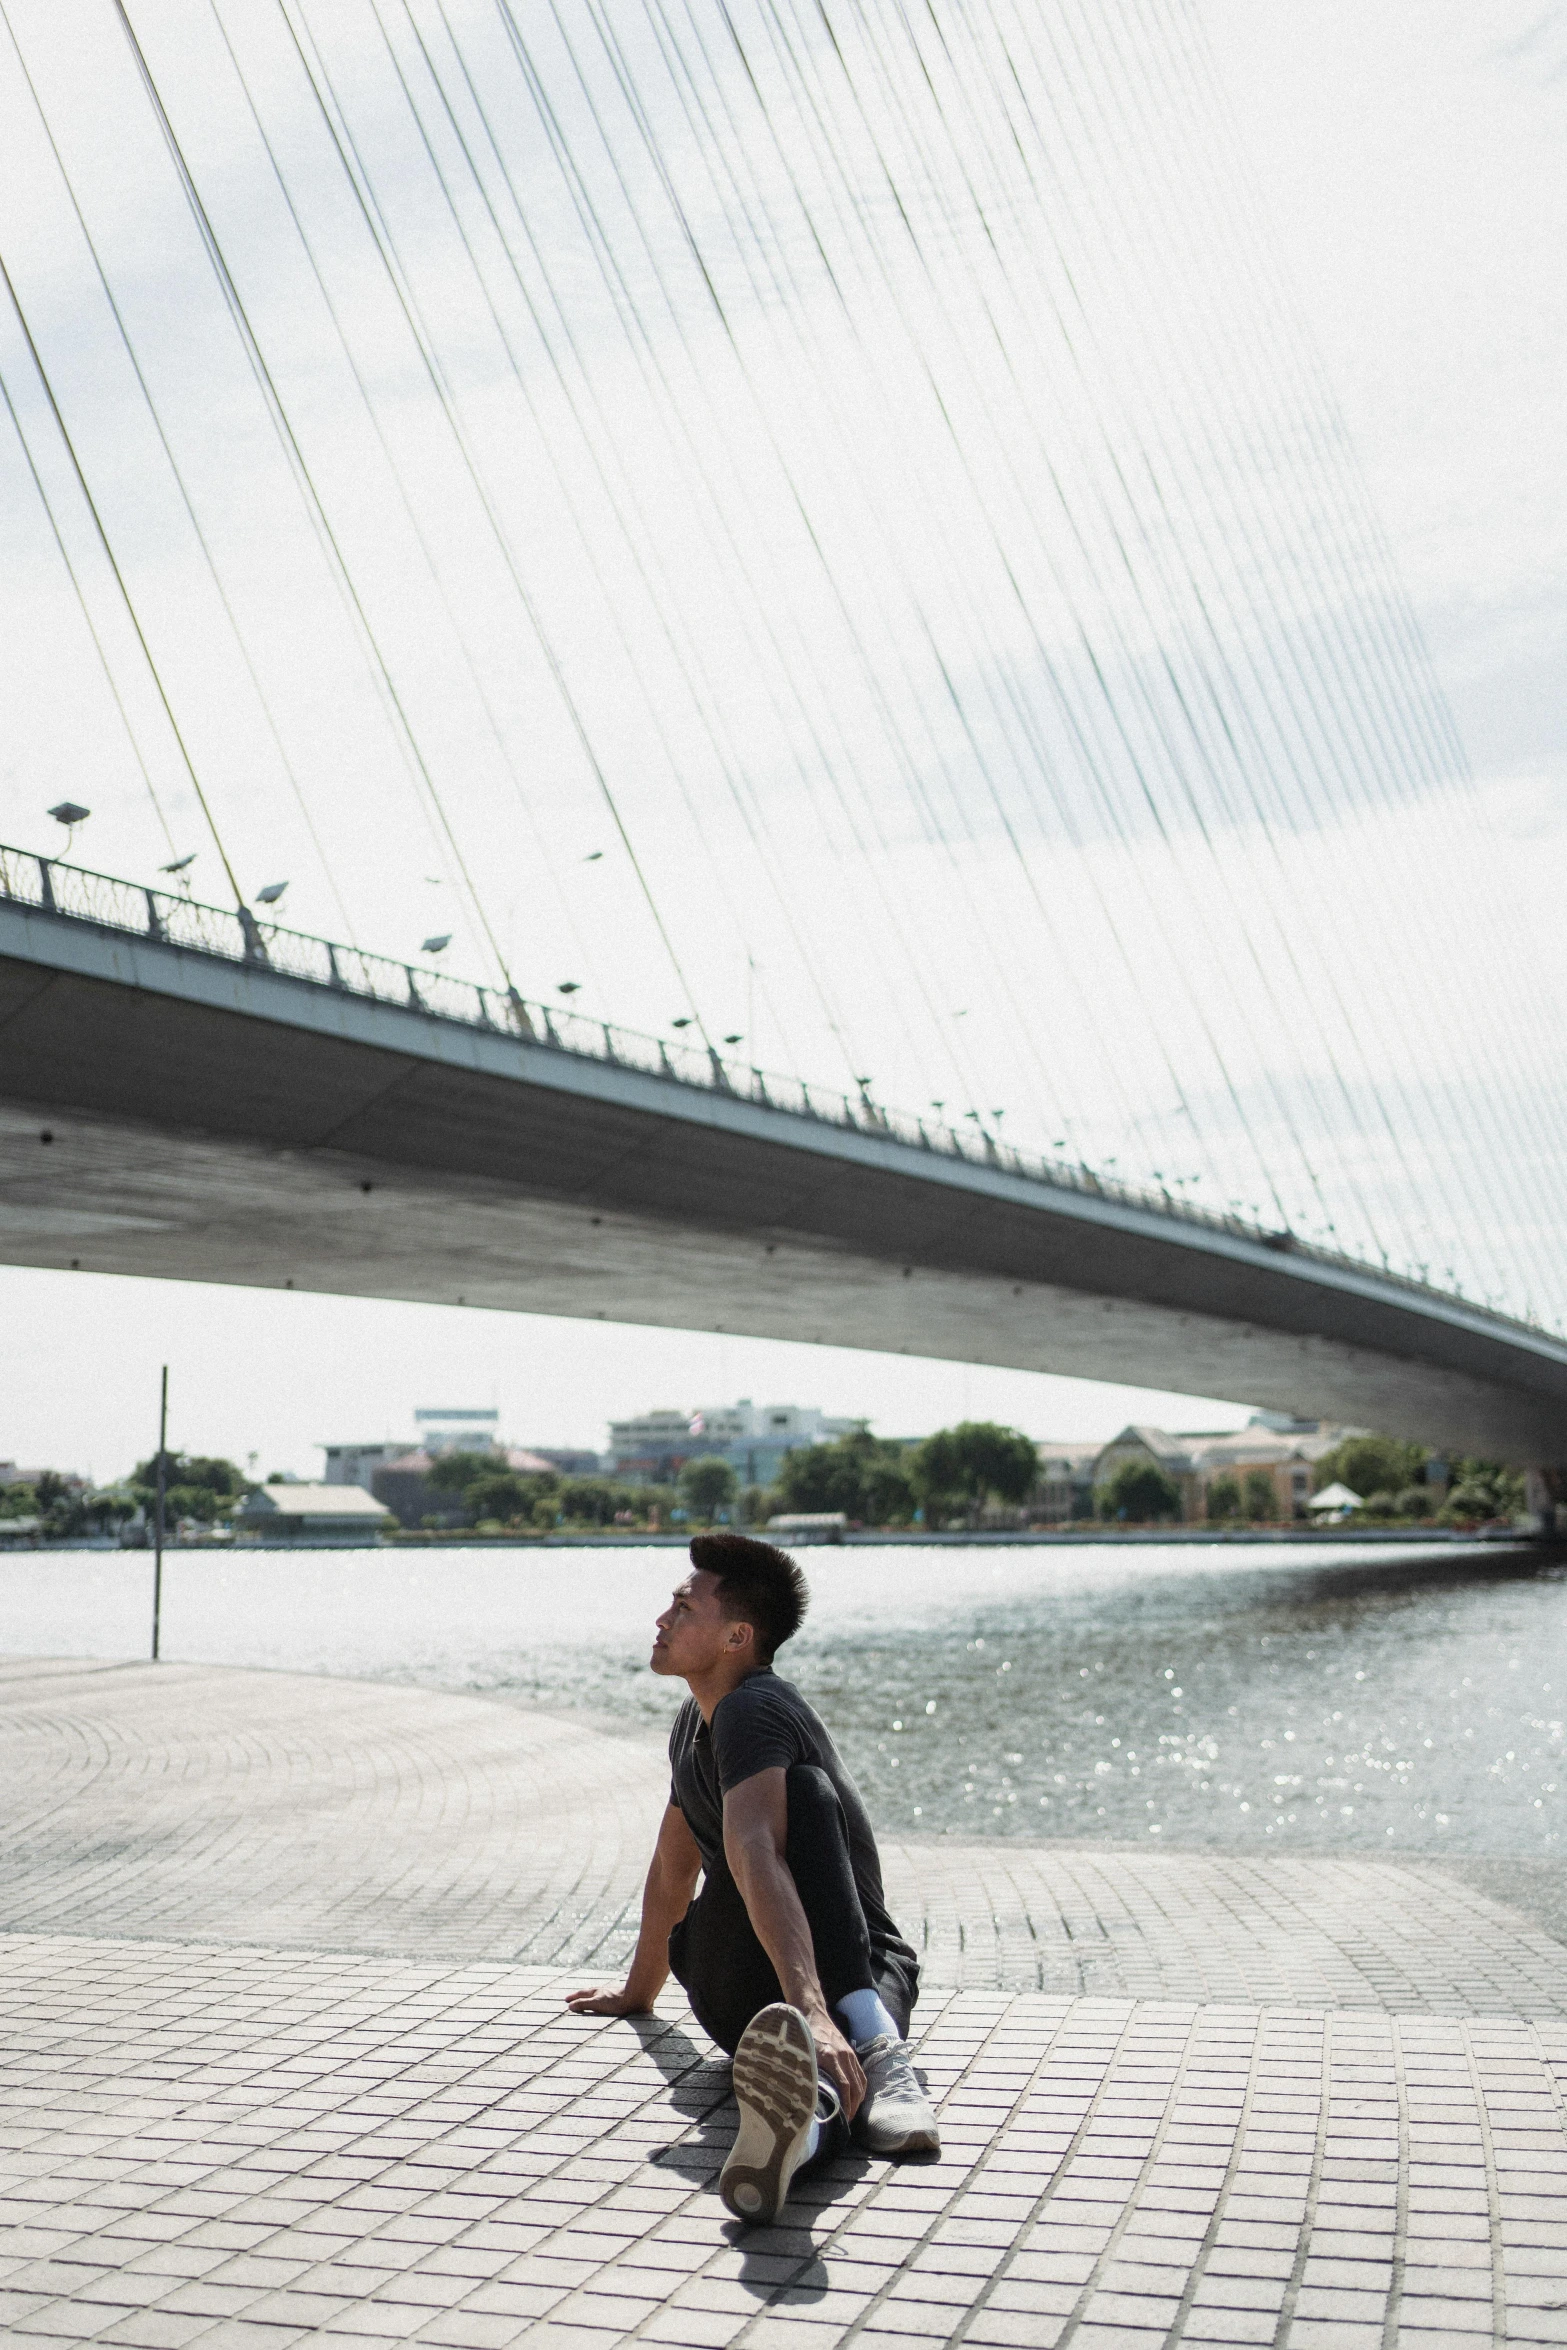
[0,844,1534,1330]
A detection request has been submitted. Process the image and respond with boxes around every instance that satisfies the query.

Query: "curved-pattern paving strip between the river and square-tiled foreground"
[0,1661,1567,2016]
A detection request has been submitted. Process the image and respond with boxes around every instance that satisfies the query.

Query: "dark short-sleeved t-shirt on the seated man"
[670,1664,919,1981]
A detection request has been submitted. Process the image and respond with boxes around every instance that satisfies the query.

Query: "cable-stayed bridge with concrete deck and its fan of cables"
[0,0,1567,1462]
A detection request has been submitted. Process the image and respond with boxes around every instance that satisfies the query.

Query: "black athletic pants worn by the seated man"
[670,1763,916,2056]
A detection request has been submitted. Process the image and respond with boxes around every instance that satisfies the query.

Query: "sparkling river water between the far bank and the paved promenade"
[0,1544,1567,1859]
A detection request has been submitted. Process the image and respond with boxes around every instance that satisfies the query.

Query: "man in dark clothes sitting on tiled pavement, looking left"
[566,1535,940,2221]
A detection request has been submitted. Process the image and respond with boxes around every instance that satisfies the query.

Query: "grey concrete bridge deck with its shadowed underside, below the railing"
[0,909,1567,1464]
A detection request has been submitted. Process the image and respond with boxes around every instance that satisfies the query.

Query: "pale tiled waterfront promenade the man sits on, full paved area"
[0,1659,1567,2350]
